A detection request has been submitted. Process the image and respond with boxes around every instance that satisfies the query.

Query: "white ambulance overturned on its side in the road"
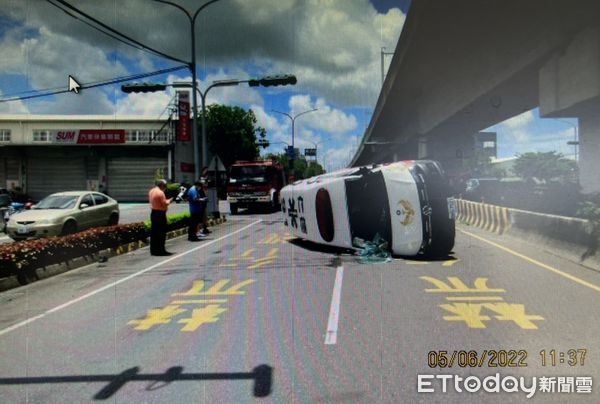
[281,160,455,256]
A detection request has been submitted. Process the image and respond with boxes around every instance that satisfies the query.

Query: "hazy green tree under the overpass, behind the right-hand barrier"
[512,151,578,182]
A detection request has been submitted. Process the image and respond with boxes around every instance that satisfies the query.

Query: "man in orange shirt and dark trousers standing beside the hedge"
[148,180,173,256]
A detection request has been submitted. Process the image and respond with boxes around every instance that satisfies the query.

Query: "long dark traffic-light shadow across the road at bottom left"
[0,364,273,400]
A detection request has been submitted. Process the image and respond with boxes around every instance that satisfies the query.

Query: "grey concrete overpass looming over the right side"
[352,0,600,192]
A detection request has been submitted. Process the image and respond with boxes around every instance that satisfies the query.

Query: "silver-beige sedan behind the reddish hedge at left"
[6,191,119,240]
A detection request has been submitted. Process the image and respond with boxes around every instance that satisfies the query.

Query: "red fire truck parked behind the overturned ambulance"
[227,160,285,215]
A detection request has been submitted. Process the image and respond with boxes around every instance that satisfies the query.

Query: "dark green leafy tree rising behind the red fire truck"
[206,104,266,167]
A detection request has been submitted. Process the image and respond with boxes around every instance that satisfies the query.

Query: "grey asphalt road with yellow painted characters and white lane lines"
[0,210,600,403]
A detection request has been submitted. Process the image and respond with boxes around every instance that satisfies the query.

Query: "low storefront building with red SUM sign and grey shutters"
[0,115,193,202]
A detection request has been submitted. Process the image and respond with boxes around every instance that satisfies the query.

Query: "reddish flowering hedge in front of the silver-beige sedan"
[0,223,148,277]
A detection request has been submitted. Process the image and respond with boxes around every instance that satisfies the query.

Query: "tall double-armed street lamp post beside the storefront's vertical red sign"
[154,0,219,179]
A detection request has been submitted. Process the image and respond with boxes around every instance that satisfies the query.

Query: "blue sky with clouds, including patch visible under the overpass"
[0,0,574,170]
